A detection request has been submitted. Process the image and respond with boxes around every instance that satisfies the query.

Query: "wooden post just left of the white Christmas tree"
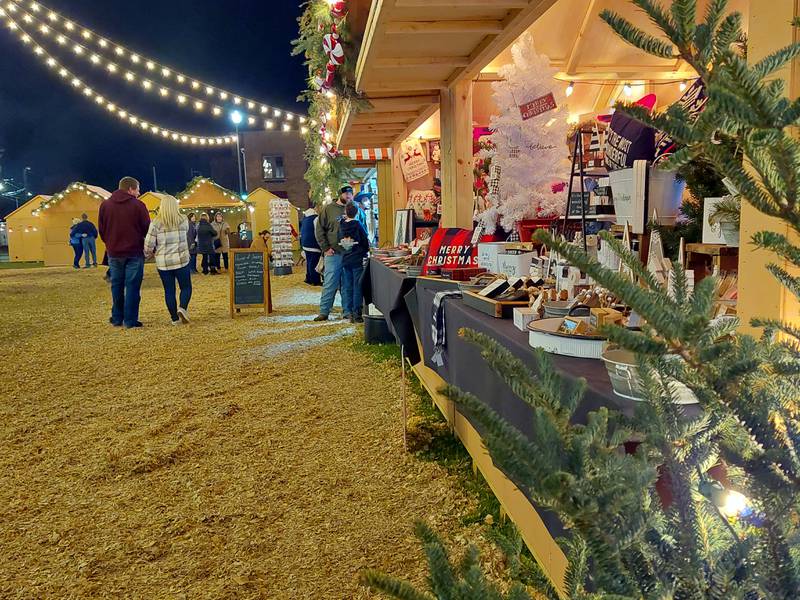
[441,81,474,229]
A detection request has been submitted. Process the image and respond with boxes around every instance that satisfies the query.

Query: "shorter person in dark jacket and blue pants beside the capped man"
[339,202,369,323]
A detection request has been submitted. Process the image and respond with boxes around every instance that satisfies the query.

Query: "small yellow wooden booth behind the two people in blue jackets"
[33,183,111,267]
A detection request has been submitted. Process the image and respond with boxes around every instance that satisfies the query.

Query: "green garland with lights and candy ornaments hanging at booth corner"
[292,0,368,204]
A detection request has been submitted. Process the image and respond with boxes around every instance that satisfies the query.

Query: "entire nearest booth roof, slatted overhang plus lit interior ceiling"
[338,0,748,150]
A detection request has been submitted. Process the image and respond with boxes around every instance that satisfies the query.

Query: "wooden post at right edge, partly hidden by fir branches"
[738,0,800,333]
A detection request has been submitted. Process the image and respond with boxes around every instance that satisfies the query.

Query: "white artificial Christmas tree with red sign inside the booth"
[480,34,570,233]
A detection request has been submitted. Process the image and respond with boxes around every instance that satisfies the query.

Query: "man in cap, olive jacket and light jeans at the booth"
[314,185,353,321]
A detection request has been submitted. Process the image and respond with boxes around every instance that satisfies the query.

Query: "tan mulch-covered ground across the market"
[0,267,482,599]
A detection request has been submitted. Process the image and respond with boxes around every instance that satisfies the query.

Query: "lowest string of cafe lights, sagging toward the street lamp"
[0,9,236,147]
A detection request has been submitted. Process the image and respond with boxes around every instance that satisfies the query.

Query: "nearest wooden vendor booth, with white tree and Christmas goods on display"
[329,0,768,585]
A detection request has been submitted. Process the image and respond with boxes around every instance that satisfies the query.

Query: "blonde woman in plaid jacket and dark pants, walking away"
[144,196,192,325]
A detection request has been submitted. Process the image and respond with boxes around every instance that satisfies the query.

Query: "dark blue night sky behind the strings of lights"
[0,0,305,194]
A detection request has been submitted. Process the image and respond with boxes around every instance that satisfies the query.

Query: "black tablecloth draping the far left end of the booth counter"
[362,258,420,364]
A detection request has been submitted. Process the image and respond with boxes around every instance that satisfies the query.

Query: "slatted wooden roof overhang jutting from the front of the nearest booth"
[339,0,556,150]
